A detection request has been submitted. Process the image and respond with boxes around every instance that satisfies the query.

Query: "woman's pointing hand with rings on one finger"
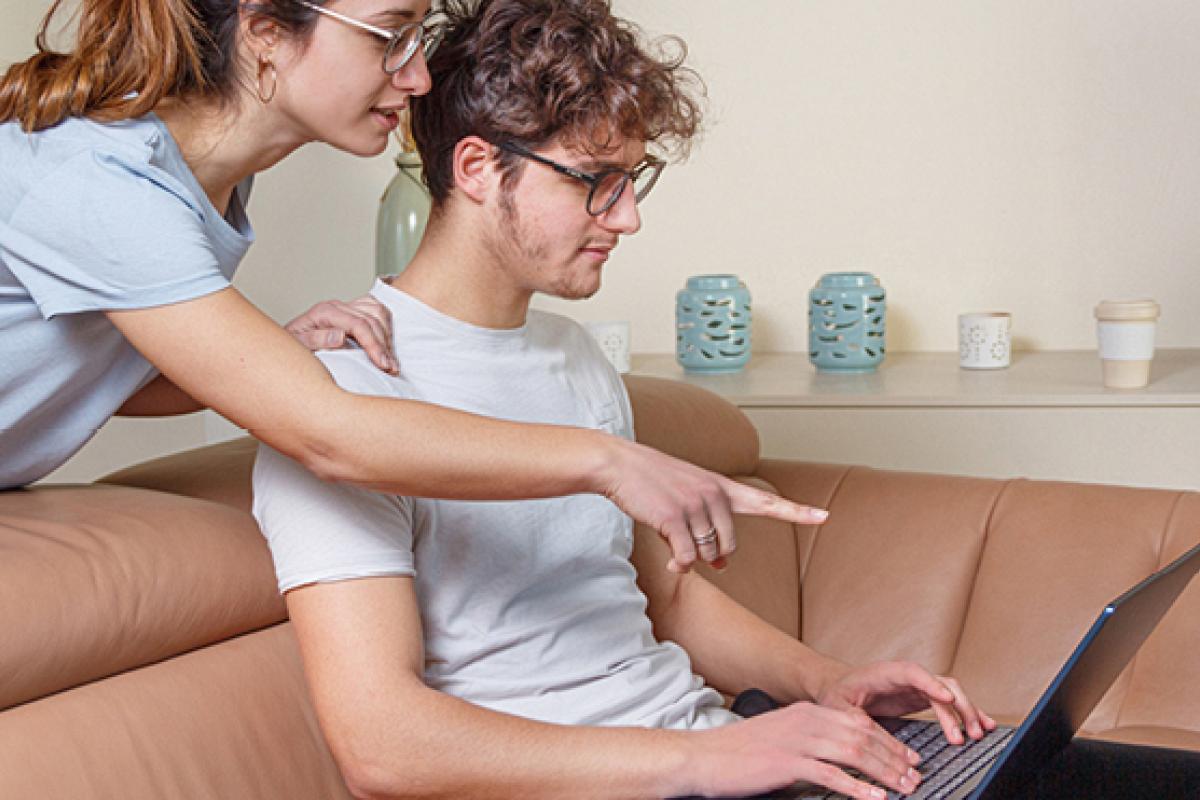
[600,439,829,572]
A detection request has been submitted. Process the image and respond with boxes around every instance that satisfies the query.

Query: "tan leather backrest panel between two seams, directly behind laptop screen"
[954,481,1178,730]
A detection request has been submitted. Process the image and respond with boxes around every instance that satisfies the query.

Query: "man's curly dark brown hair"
[412,0,704,205]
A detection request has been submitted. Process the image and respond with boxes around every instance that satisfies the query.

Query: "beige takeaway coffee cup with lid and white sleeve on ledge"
[1096,300,1159,389]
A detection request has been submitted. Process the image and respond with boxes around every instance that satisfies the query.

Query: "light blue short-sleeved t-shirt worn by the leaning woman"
[0,114,253,489]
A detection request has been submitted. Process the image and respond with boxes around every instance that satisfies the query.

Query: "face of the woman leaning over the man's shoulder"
[271,0,430,156]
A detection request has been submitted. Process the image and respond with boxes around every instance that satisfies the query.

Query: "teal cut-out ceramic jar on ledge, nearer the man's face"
[676,275,750,372]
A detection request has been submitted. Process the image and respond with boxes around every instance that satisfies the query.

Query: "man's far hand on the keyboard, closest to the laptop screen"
[817,661,996,745]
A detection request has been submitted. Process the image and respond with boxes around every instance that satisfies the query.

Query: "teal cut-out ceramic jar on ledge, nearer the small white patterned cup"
[809,272,887,372]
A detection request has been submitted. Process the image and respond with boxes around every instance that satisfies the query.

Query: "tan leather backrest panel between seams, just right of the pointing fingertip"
[792,468,1003,688]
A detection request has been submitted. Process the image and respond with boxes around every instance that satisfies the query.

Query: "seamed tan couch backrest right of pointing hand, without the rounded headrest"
[736,461,1200,746]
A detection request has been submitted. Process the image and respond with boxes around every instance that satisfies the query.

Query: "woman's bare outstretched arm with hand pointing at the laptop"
[107,288,823,569]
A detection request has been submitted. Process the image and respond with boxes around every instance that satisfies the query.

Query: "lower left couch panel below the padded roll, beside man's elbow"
[0,624,349,800]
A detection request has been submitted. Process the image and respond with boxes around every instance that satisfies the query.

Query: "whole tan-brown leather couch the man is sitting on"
[0,378,1200,800]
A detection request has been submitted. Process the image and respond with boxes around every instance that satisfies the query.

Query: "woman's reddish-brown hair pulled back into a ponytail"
[0,0,319,132]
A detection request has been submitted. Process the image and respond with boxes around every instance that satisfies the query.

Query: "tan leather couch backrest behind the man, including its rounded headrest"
[93,377,1200,746]
